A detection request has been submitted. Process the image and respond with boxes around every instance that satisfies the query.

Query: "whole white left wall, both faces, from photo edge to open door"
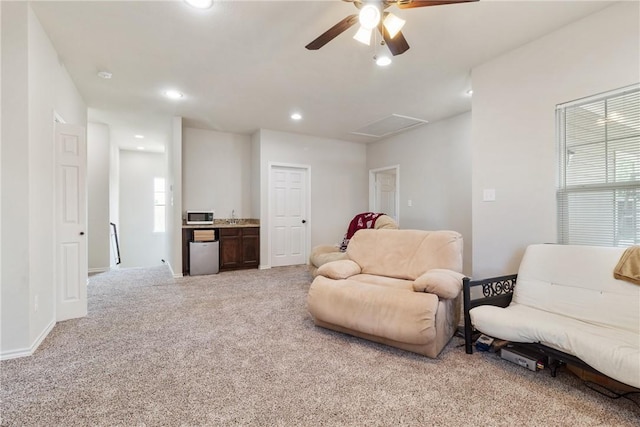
[0,2,87,358]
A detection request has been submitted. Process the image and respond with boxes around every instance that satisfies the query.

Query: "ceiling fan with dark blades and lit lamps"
[305,0,478,56]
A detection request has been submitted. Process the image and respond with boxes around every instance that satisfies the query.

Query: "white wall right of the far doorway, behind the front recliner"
[367,113,472,274]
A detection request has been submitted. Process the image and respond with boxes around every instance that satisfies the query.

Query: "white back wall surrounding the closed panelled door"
[252,129,369,268]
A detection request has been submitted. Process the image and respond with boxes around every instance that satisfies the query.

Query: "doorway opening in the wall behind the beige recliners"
[369,165,400,224]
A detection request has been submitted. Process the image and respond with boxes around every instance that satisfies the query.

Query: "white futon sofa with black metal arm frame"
[464,244,640,388]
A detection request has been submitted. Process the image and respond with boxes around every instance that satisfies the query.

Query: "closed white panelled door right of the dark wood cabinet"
[270,166,308,267]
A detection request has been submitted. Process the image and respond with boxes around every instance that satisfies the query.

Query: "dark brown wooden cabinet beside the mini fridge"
[219,227,260,271]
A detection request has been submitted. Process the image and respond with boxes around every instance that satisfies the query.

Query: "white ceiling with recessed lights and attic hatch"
[32,0,611,150]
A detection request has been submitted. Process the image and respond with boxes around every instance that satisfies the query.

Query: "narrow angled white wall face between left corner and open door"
[28,2,87,339]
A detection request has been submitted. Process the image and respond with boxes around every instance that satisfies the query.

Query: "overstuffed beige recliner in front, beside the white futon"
[307,230,464,357]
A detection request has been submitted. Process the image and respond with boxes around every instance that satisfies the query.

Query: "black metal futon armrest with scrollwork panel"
[462,274,518,354]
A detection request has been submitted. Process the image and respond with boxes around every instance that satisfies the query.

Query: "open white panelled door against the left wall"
[55,123,88,321]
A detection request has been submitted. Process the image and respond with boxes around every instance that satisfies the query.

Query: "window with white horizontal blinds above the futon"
[556,85,640,247]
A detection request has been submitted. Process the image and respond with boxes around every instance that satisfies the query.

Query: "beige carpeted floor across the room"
[0,266,640,426]
